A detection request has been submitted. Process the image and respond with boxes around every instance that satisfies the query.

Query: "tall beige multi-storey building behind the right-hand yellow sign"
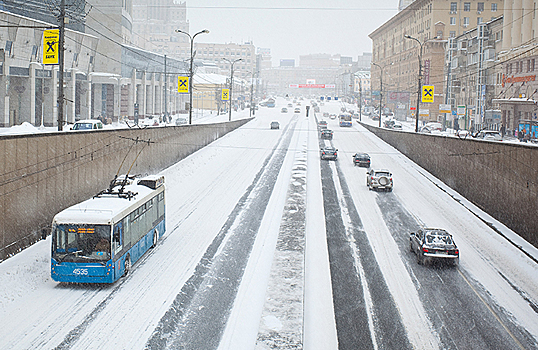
[369,0,504,121]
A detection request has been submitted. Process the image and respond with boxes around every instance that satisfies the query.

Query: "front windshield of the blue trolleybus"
[52,224,111,262]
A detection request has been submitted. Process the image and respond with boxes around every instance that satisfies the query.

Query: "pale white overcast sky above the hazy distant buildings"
[186,0,398,65]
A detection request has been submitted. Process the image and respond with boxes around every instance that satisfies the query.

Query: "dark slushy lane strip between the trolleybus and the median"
[146,116,297,350]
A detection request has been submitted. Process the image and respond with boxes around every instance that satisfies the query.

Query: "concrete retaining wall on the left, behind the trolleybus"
[0,119,250,261]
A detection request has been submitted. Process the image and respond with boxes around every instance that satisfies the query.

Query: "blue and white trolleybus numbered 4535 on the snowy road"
[51,176,165,283]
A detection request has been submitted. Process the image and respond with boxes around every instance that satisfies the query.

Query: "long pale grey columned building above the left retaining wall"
[0,0,187,127]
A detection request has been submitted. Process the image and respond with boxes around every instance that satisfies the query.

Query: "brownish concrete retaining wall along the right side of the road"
[362,124,538,247]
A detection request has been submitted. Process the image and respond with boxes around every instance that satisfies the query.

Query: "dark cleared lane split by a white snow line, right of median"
[320,133,412,349]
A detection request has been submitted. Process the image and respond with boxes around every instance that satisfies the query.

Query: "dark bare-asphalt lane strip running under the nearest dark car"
[376,193,534,349]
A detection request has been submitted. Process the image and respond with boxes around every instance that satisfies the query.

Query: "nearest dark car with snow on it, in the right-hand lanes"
[409,228,460,265]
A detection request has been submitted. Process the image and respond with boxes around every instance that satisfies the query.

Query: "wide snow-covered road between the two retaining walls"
[0,99,538,349]
